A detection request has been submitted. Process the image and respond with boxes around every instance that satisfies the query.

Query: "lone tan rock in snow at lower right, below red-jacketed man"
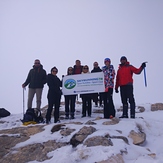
[128,130,146,145]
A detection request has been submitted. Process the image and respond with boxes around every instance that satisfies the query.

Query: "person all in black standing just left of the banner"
[46,67,62,124]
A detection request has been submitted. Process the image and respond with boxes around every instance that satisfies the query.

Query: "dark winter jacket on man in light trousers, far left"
[23,65,46,88]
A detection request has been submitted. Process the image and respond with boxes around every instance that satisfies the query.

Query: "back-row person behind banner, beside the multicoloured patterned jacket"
[91,62,102,107]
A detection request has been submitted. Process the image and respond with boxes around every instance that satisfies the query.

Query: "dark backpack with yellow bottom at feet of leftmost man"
[21,108,44,125]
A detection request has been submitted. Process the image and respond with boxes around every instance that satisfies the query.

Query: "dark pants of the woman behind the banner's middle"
[81,94,92,116]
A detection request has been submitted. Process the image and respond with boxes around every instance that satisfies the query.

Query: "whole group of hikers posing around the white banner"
[22,56,146,124]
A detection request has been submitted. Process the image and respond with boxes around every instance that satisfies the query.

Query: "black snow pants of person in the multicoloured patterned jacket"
[103,88,115,118]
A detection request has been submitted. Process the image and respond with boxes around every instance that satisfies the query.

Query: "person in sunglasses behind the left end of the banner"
[64,67,76,119]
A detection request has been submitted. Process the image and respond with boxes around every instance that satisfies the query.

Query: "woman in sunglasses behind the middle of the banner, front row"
[80,65,92,118]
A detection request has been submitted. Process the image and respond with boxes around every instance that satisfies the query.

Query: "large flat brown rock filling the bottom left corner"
[0,140,67,163]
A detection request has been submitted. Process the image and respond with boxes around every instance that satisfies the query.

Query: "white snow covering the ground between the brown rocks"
[0,104,163,163]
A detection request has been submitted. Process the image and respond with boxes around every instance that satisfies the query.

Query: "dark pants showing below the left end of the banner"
[64,95,76,117]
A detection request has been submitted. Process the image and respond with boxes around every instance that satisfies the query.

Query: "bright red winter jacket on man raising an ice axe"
[115,62,143,89]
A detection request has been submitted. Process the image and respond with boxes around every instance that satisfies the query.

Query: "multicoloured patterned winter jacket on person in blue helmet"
[102,65,115,89]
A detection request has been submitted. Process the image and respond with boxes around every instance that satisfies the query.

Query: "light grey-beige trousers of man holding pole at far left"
[27,88,43,110]
